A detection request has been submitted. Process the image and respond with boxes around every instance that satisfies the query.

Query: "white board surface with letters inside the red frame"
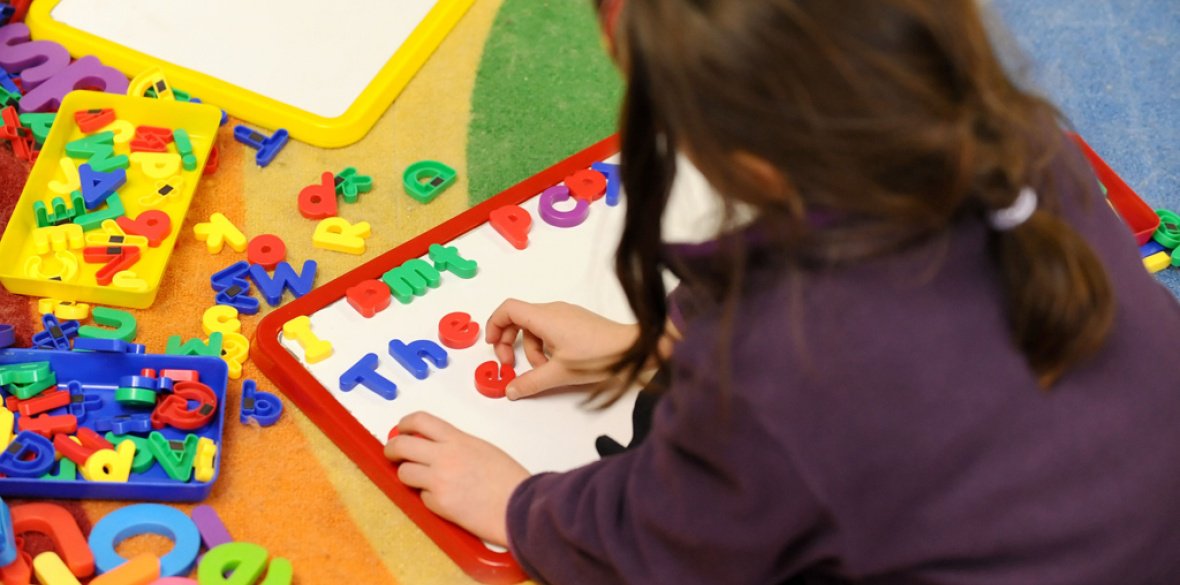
[282,159,717,473]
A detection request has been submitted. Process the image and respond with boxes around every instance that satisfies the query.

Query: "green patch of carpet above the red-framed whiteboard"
[467,0,623,205]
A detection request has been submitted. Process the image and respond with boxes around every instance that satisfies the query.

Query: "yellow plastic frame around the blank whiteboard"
[25,0,476,147]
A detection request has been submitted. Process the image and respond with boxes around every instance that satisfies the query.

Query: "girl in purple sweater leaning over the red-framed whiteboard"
[387,0,1180,585]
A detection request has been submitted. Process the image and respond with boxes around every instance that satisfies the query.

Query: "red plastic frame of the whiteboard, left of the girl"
[250,136,618,585]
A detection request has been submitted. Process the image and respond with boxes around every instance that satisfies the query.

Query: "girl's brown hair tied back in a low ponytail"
[599,0,1115,401]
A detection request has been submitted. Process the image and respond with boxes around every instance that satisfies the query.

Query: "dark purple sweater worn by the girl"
[507,149,1180,585]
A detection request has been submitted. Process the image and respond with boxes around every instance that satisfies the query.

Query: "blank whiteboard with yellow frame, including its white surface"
[26,0,474,147]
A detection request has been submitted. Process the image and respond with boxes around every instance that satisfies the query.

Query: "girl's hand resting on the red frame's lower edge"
[385,413,529,546]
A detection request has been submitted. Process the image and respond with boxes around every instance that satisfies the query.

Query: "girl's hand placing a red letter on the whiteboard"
[486,298,638,400]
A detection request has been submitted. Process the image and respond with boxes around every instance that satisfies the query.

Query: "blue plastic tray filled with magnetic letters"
[0,349,229,501]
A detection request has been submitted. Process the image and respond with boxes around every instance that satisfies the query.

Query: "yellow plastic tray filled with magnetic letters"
[0,91,221,309]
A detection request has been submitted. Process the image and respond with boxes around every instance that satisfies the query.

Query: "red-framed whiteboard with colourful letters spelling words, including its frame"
[251,138,716,583]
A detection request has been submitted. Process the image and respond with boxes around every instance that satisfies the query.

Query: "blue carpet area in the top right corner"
[990,0,1180,296]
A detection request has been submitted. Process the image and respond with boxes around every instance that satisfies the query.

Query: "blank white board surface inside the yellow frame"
[51,0,437,118]
